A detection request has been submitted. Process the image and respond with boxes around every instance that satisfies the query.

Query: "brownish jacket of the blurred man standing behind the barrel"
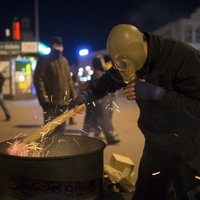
[34,51,75,106]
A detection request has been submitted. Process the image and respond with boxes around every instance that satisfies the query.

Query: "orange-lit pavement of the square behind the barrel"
[0,95,144,199]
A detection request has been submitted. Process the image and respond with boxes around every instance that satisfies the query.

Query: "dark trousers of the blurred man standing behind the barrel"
[43,105,67,133]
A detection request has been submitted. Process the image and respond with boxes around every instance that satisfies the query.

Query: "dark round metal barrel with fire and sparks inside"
[0,135,105,200]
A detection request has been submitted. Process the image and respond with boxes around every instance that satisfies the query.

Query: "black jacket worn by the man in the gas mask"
[88,33,200,161]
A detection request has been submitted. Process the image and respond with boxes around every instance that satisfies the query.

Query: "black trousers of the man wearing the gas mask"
[132,135,200,200]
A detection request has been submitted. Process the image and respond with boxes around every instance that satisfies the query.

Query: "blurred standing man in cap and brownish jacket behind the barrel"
[34,36,75,133]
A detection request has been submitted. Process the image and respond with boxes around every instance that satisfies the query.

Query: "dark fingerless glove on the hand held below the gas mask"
[135,82,165,100]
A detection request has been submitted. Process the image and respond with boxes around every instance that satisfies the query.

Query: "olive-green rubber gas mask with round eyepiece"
[107,24,147,83]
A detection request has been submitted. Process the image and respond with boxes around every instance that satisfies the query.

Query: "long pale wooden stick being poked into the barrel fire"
[23,104,85,143]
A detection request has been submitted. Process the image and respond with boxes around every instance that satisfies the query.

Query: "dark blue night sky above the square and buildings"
[0,0,200,64]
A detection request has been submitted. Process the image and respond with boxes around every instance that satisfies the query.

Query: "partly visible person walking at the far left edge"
[0,72,11,121]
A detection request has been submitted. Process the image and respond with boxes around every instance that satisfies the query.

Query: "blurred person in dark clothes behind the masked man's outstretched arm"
[83,55,120,145]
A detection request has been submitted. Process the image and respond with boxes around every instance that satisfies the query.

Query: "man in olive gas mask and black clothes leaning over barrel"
[71,24,200,200]
